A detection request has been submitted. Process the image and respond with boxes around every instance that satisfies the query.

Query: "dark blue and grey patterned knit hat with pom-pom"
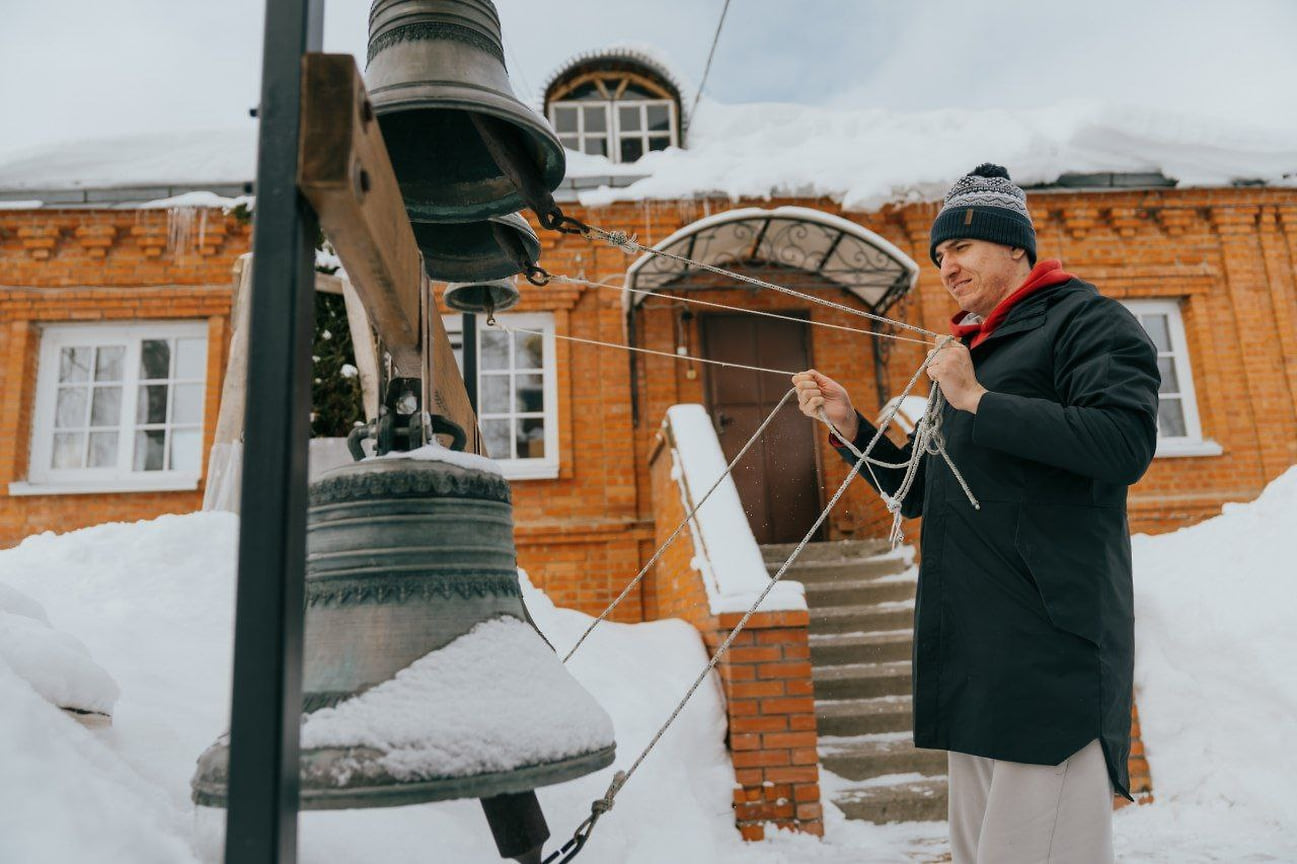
[927,162,1036,267]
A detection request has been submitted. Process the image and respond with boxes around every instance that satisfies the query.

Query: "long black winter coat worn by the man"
[840,279,1160,797]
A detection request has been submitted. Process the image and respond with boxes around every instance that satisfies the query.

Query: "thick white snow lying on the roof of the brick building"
[0,99,1297,210]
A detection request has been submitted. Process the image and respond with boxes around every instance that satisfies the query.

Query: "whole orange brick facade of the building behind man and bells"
[0,188,1297,576]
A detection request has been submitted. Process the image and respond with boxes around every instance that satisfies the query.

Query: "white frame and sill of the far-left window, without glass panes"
[9,320,209,496]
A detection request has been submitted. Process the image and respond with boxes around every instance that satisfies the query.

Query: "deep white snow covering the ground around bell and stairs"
[0,470,1297,864]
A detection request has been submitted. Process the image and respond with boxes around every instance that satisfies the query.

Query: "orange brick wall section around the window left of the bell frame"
[0,209,249,546]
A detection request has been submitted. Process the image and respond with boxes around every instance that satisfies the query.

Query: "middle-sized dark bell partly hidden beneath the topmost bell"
[410,213,541,282]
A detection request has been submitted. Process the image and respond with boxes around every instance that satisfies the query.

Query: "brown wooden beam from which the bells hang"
[297,53,481,453]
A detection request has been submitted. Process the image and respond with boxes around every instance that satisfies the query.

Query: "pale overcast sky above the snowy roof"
[0,0,1297,150]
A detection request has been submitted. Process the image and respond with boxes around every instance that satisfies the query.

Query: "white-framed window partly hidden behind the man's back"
[1124,300,1222,457]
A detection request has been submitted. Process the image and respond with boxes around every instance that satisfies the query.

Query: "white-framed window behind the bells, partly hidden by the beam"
[442,313,559,479]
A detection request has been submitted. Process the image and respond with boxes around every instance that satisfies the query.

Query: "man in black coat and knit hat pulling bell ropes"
[792,165,1160,864]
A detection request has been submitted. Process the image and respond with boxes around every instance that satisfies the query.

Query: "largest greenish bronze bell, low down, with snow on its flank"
[192,446,615,861]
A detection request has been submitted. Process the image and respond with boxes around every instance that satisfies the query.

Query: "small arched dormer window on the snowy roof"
[550,74,680,162]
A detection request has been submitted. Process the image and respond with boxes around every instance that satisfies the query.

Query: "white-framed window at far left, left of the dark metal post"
[10,322,208,494]
